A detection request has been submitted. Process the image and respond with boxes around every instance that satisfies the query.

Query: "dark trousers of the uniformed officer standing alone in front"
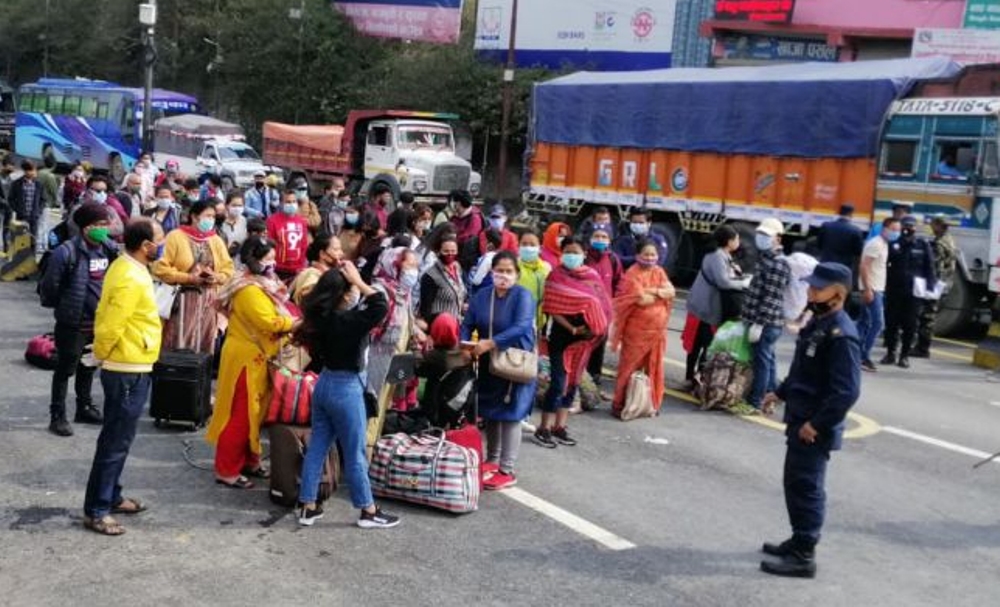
[784,436,830,546]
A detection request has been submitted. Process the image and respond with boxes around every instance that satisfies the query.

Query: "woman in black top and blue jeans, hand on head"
[296,261,399,529]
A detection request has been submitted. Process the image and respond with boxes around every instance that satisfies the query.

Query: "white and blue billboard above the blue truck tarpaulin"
[476,0,676,70]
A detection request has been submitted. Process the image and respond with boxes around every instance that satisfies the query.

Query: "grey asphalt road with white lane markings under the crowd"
[0,283,1000,607]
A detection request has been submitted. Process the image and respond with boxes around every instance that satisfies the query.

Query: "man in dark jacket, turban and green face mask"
[39,203,117,436]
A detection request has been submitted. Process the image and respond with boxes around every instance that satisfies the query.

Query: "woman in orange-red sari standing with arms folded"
[611,241,676,417]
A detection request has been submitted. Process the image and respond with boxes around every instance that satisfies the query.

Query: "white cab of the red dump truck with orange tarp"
[362,119,482,197]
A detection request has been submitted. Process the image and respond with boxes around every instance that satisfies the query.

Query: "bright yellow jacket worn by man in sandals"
[94,253,163,373]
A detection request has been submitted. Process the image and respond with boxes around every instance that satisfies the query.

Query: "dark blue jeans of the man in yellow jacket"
[83,370,151,518]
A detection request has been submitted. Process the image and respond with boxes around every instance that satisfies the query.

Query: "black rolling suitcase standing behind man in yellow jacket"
[149,288,213,428]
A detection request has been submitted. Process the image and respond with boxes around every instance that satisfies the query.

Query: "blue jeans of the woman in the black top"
[299,370,375,509]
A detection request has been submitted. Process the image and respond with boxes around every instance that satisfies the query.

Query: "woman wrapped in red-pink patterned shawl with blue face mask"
[535,236,611,449]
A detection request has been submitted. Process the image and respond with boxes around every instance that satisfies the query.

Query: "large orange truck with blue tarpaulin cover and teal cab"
[525,58,1000,333]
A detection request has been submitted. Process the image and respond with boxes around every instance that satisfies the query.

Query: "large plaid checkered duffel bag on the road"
[368,430,480,514]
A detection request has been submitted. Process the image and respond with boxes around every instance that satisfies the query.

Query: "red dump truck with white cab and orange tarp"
[264,110,482,203]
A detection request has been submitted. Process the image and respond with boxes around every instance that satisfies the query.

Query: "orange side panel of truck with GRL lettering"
[530,143,875,225]
